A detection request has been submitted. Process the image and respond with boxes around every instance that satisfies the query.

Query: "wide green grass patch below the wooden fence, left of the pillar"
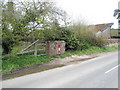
[2,55,53,74]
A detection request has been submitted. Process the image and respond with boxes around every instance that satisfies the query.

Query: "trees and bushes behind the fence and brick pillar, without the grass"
[2,2,105,54]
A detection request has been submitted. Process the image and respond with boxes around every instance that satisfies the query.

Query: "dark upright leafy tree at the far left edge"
[1,2,18,54]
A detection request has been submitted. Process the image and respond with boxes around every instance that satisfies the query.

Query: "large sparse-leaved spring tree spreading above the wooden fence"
[1,1,66,54]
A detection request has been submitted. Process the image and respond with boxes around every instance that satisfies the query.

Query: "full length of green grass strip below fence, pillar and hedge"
[2,46,118,74]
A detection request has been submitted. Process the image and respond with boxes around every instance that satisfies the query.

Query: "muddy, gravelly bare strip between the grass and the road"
[3,46,117,80]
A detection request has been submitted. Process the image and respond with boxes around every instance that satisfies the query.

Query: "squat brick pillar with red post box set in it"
[46,41,65,56]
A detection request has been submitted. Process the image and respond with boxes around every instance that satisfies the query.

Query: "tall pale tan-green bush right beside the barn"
[70,24,105,49]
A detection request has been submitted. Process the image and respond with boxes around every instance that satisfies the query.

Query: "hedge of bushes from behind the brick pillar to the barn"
[44,24,105,50]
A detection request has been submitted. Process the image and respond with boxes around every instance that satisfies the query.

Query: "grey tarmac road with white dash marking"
[2,52,119,88]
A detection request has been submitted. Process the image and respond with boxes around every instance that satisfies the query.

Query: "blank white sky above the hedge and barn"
[53,0,119,28]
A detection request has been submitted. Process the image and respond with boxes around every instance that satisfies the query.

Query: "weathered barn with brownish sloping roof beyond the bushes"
[90,23,113,39]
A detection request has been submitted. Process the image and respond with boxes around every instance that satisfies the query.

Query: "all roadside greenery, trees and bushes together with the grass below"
[0,0,117,74]
